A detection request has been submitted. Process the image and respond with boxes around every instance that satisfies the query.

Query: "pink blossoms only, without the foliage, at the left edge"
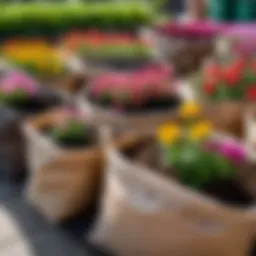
[0,71,38,96]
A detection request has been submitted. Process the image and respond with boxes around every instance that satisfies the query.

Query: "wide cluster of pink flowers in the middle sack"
[89,65,177,109]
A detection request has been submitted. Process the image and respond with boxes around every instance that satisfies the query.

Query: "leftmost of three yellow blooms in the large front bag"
[157,124,181,144]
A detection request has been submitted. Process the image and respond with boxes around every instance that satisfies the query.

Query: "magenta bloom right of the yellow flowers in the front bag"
[218,142,246,163]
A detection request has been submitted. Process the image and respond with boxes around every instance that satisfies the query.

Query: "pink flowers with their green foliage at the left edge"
[0,71,39,106]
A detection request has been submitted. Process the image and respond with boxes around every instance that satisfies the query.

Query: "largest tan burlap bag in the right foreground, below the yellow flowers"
[91,133,256,256]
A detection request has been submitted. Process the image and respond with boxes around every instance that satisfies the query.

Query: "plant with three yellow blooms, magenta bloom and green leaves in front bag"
[157,103,245,188]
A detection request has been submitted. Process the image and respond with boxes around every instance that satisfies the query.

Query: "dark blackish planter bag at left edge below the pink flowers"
[0,89,59,180]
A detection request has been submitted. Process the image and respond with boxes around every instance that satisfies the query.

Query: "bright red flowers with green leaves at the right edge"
[200,59,256,101]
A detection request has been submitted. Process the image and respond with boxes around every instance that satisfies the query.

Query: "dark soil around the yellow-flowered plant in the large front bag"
[124,139,256,207]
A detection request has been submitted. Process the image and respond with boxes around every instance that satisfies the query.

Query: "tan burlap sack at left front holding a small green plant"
[23,110,138,222]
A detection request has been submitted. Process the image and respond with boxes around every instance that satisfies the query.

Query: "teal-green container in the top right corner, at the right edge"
[236,0,256,22]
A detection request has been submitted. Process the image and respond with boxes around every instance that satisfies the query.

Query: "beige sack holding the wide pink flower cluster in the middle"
[77,81,194,131]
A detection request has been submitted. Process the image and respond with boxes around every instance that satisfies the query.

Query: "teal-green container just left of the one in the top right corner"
[208,0,236,21]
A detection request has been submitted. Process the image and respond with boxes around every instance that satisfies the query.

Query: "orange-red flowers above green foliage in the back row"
[62,30,151,69]
